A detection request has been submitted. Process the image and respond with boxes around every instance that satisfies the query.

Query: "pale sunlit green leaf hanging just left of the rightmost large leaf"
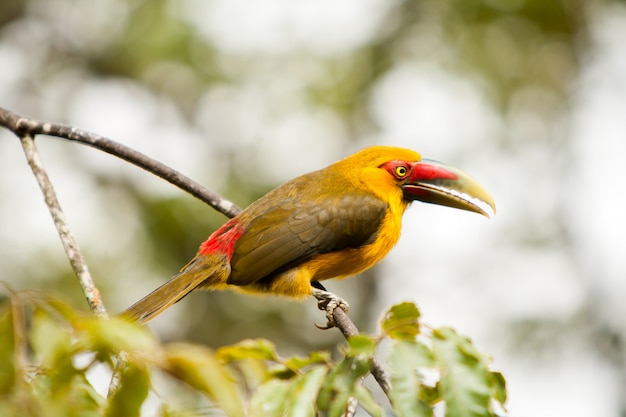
[389,340,434,417]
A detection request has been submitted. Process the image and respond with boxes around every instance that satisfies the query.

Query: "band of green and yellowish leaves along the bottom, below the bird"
[0,293,506,417]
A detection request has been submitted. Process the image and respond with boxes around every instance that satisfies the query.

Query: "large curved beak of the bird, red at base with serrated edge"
[401,159,496,217]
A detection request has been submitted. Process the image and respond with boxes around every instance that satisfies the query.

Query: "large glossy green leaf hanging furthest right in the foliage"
[433,328,493,417]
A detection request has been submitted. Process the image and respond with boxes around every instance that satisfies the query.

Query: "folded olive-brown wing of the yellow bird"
[228,192,387,285]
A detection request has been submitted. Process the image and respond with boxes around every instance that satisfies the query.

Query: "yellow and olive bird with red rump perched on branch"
[121,146,496,327]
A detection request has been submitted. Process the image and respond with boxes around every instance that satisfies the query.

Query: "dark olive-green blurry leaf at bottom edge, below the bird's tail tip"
[105,362,150,417]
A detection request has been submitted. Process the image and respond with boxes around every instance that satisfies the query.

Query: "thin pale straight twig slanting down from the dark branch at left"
[21,133,107,317]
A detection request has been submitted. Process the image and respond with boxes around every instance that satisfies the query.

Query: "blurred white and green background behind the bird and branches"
[0,0,626,417]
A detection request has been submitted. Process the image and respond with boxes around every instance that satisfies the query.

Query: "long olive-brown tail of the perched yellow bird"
[120,252,230,324]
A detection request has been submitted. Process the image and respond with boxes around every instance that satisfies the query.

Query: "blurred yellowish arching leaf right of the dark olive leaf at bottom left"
[164,343,244,417]
